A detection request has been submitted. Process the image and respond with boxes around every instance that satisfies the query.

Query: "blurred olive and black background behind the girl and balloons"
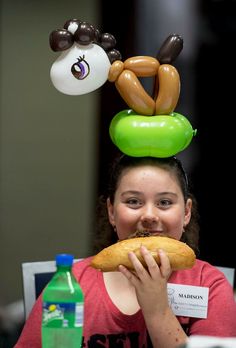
[0,0,236,348]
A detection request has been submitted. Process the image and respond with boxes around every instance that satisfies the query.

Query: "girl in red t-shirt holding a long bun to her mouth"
[15,155,236,348]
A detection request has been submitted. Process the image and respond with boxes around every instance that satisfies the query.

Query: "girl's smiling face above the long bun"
[107,165,192,240]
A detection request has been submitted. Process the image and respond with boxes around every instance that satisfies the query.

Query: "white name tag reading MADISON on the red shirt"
[167,283,209,319]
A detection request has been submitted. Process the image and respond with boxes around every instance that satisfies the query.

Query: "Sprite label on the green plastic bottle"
[42,302,84,328]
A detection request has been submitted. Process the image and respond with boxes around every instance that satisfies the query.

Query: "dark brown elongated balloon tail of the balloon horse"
[157,34,183,64]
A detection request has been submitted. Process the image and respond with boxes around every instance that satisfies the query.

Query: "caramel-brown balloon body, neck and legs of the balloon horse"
[108,56,180,115]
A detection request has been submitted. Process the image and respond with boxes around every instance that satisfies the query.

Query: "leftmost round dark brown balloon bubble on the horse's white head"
[49,29,74,52]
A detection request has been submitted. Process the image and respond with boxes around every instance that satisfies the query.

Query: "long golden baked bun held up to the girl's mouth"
[90,236,196,272]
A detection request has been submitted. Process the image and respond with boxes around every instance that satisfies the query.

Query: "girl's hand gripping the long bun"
[119,246,171,316]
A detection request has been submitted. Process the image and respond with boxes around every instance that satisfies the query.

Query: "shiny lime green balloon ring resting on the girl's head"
[109,110,196,157]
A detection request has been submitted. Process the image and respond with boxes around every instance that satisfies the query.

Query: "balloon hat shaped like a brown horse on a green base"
[49,19,196,157]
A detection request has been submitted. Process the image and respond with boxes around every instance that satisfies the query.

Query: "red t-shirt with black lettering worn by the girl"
[14,258,236,348]
